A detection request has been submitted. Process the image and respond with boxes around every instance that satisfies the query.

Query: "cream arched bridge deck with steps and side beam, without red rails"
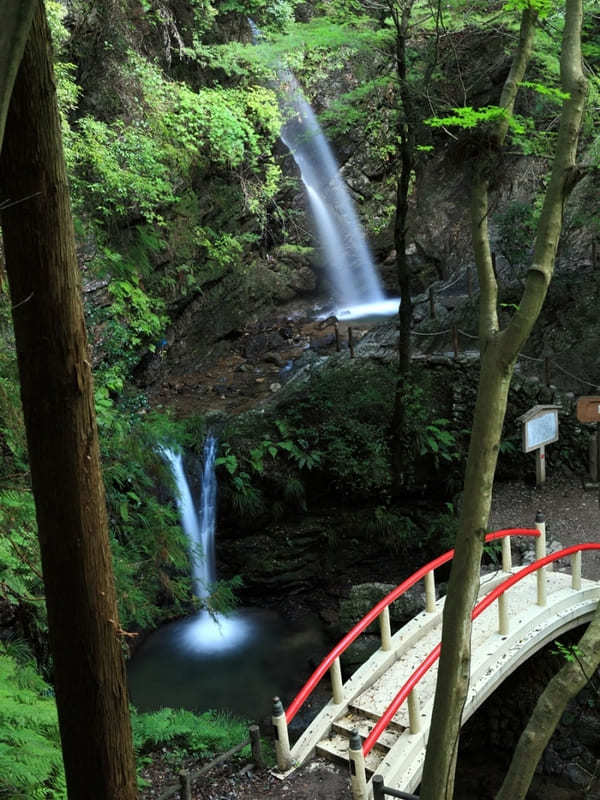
[284,570,600,793]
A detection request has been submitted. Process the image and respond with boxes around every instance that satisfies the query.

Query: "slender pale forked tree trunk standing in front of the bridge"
[420,0,586,800]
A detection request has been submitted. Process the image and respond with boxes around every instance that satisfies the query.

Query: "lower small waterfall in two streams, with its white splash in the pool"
[163,434,250,652]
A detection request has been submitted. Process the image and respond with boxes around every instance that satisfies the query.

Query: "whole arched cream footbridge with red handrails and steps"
[273,521,600,800]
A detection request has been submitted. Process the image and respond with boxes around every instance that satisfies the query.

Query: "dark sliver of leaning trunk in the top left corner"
[0,0,37,150]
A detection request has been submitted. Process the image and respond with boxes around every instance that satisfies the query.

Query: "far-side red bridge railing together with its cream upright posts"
[285,528,540,724]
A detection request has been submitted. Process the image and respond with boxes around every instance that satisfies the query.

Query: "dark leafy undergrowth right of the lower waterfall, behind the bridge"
[209,363,465,527]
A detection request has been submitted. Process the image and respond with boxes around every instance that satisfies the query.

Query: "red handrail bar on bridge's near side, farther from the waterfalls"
[363,537,600,756]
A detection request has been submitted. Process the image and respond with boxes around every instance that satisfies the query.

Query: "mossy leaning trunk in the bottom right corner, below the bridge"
[496,606,600,800]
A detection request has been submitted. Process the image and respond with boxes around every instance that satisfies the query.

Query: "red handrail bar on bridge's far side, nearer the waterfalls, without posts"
[285,528,540,724]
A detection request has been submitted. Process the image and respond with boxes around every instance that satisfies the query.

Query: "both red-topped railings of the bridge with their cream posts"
[273,513,600,800]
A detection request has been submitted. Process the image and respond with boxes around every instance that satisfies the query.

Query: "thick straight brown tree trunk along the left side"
[0,3,137,800]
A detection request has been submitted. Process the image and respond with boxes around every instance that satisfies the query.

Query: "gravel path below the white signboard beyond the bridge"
[489,475,600,580]
